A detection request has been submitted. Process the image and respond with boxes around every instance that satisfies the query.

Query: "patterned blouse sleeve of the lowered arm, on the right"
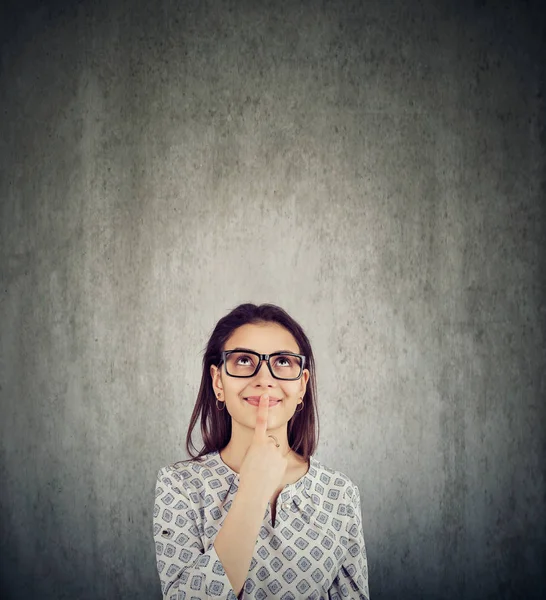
[328,484,370,600]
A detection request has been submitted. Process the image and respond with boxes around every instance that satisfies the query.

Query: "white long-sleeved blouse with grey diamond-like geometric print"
[153,450,369,600]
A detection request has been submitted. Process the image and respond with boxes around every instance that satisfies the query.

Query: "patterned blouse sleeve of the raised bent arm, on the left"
[153,467,237,600]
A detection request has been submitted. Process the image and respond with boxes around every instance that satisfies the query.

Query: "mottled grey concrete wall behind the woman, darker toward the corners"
[0,0,546,600]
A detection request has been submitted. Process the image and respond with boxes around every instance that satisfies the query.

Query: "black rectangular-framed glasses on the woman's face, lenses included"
[218,350,305,381]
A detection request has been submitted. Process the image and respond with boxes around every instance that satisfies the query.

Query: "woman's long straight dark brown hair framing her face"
[186,304,320,462]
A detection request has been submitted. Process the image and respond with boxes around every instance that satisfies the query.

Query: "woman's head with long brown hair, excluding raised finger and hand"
[186,304,318,459]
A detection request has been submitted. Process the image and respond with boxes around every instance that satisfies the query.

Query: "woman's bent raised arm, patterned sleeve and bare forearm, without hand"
[153,469,266,600]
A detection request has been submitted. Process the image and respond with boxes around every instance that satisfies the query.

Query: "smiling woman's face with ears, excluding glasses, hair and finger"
[211,323,309,429]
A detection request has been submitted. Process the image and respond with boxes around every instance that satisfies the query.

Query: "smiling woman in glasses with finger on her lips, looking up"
[153,304,369,600]
